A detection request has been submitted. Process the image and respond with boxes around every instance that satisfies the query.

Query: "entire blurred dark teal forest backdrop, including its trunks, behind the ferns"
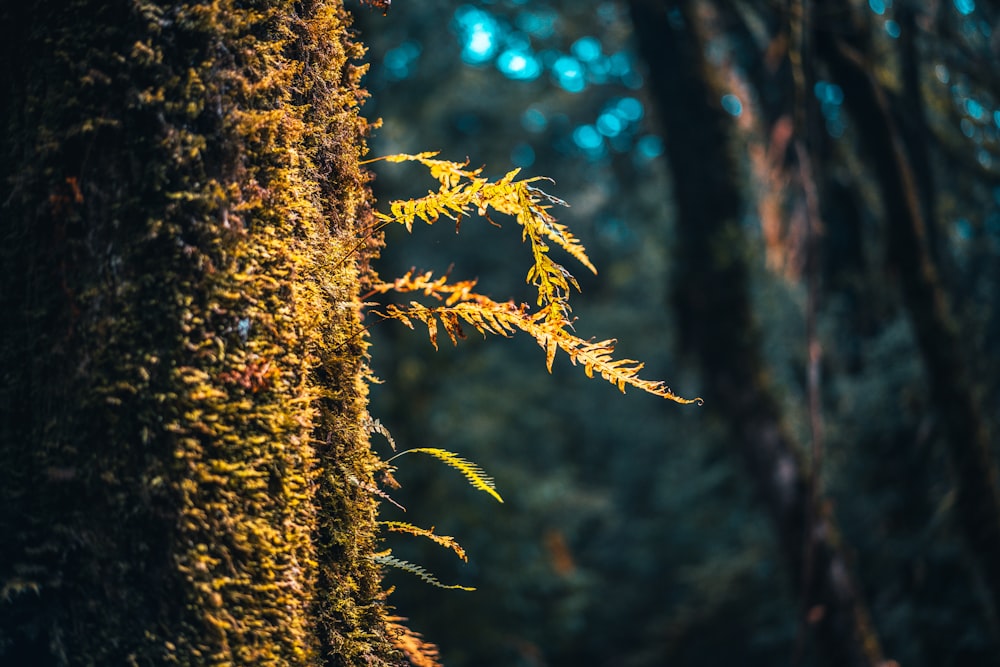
[358,0,1000,667]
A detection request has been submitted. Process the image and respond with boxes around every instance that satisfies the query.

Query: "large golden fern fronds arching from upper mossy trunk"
[372,152,702,405]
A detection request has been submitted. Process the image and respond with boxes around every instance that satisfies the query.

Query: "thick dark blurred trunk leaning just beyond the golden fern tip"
[630,0,882,667]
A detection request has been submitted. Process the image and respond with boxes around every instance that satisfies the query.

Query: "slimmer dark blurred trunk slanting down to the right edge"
[817,2,1000,614]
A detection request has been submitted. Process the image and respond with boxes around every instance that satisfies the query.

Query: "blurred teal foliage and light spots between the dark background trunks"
[348,0,1000,667]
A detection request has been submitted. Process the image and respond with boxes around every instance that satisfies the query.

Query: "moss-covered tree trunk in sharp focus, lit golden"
[0,0,393,665]
